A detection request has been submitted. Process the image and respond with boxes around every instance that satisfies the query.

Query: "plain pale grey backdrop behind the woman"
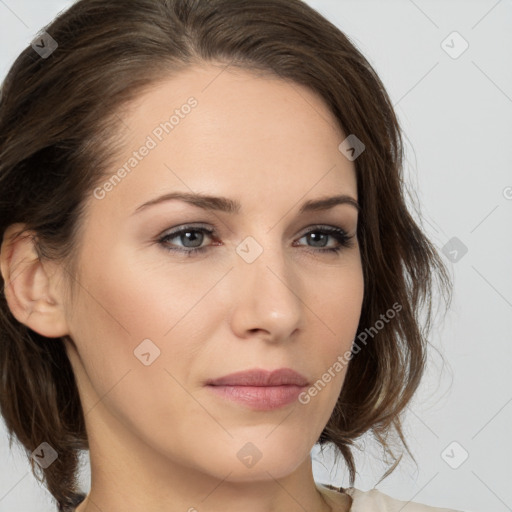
[0,0,512,512]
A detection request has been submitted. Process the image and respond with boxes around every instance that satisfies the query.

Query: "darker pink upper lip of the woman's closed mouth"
[206,368,308,386]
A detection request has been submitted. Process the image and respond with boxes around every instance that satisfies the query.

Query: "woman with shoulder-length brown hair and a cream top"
[0,0,456,512]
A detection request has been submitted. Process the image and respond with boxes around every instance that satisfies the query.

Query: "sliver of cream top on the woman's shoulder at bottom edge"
[316,483,461,512]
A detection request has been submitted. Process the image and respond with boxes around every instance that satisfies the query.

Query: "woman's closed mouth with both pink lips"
[206,368,309,411]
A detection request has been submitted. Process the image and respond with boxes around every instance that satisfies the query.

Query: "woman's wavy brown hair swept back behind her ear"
[0,0,451,511]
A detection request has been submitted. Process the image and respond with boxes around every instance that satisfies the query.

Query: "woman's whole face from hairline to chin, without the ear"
[61,66,363,481]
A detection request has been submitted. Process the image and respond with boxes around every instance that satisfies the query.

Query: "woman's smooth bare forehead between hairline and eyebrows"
[94,65,357,216]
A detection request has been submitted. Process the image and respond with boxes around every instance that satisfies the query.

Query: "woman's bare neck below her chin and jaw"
[76,412,333,512]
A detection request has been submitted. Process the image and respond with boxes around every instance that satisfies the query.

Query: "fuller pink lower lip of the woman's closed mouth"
[207,385,307,411]
